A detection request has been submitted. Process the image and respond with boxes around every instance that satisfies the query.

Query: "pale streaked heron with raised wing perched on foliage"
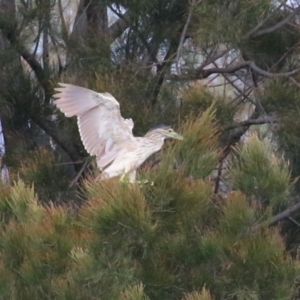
[54,83,183,182]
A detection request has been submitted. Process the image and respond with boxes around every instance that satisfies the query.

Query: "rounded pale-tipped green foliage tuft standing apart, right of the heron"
[230,134,293,208]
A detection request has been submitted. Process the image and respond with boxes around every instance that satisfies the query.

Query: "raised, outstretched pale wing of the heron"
[54,83,134,168]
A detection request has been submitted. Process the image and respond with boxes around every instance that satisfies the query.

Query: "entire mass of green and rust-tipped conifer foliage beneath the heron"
[0,109,299,300]
